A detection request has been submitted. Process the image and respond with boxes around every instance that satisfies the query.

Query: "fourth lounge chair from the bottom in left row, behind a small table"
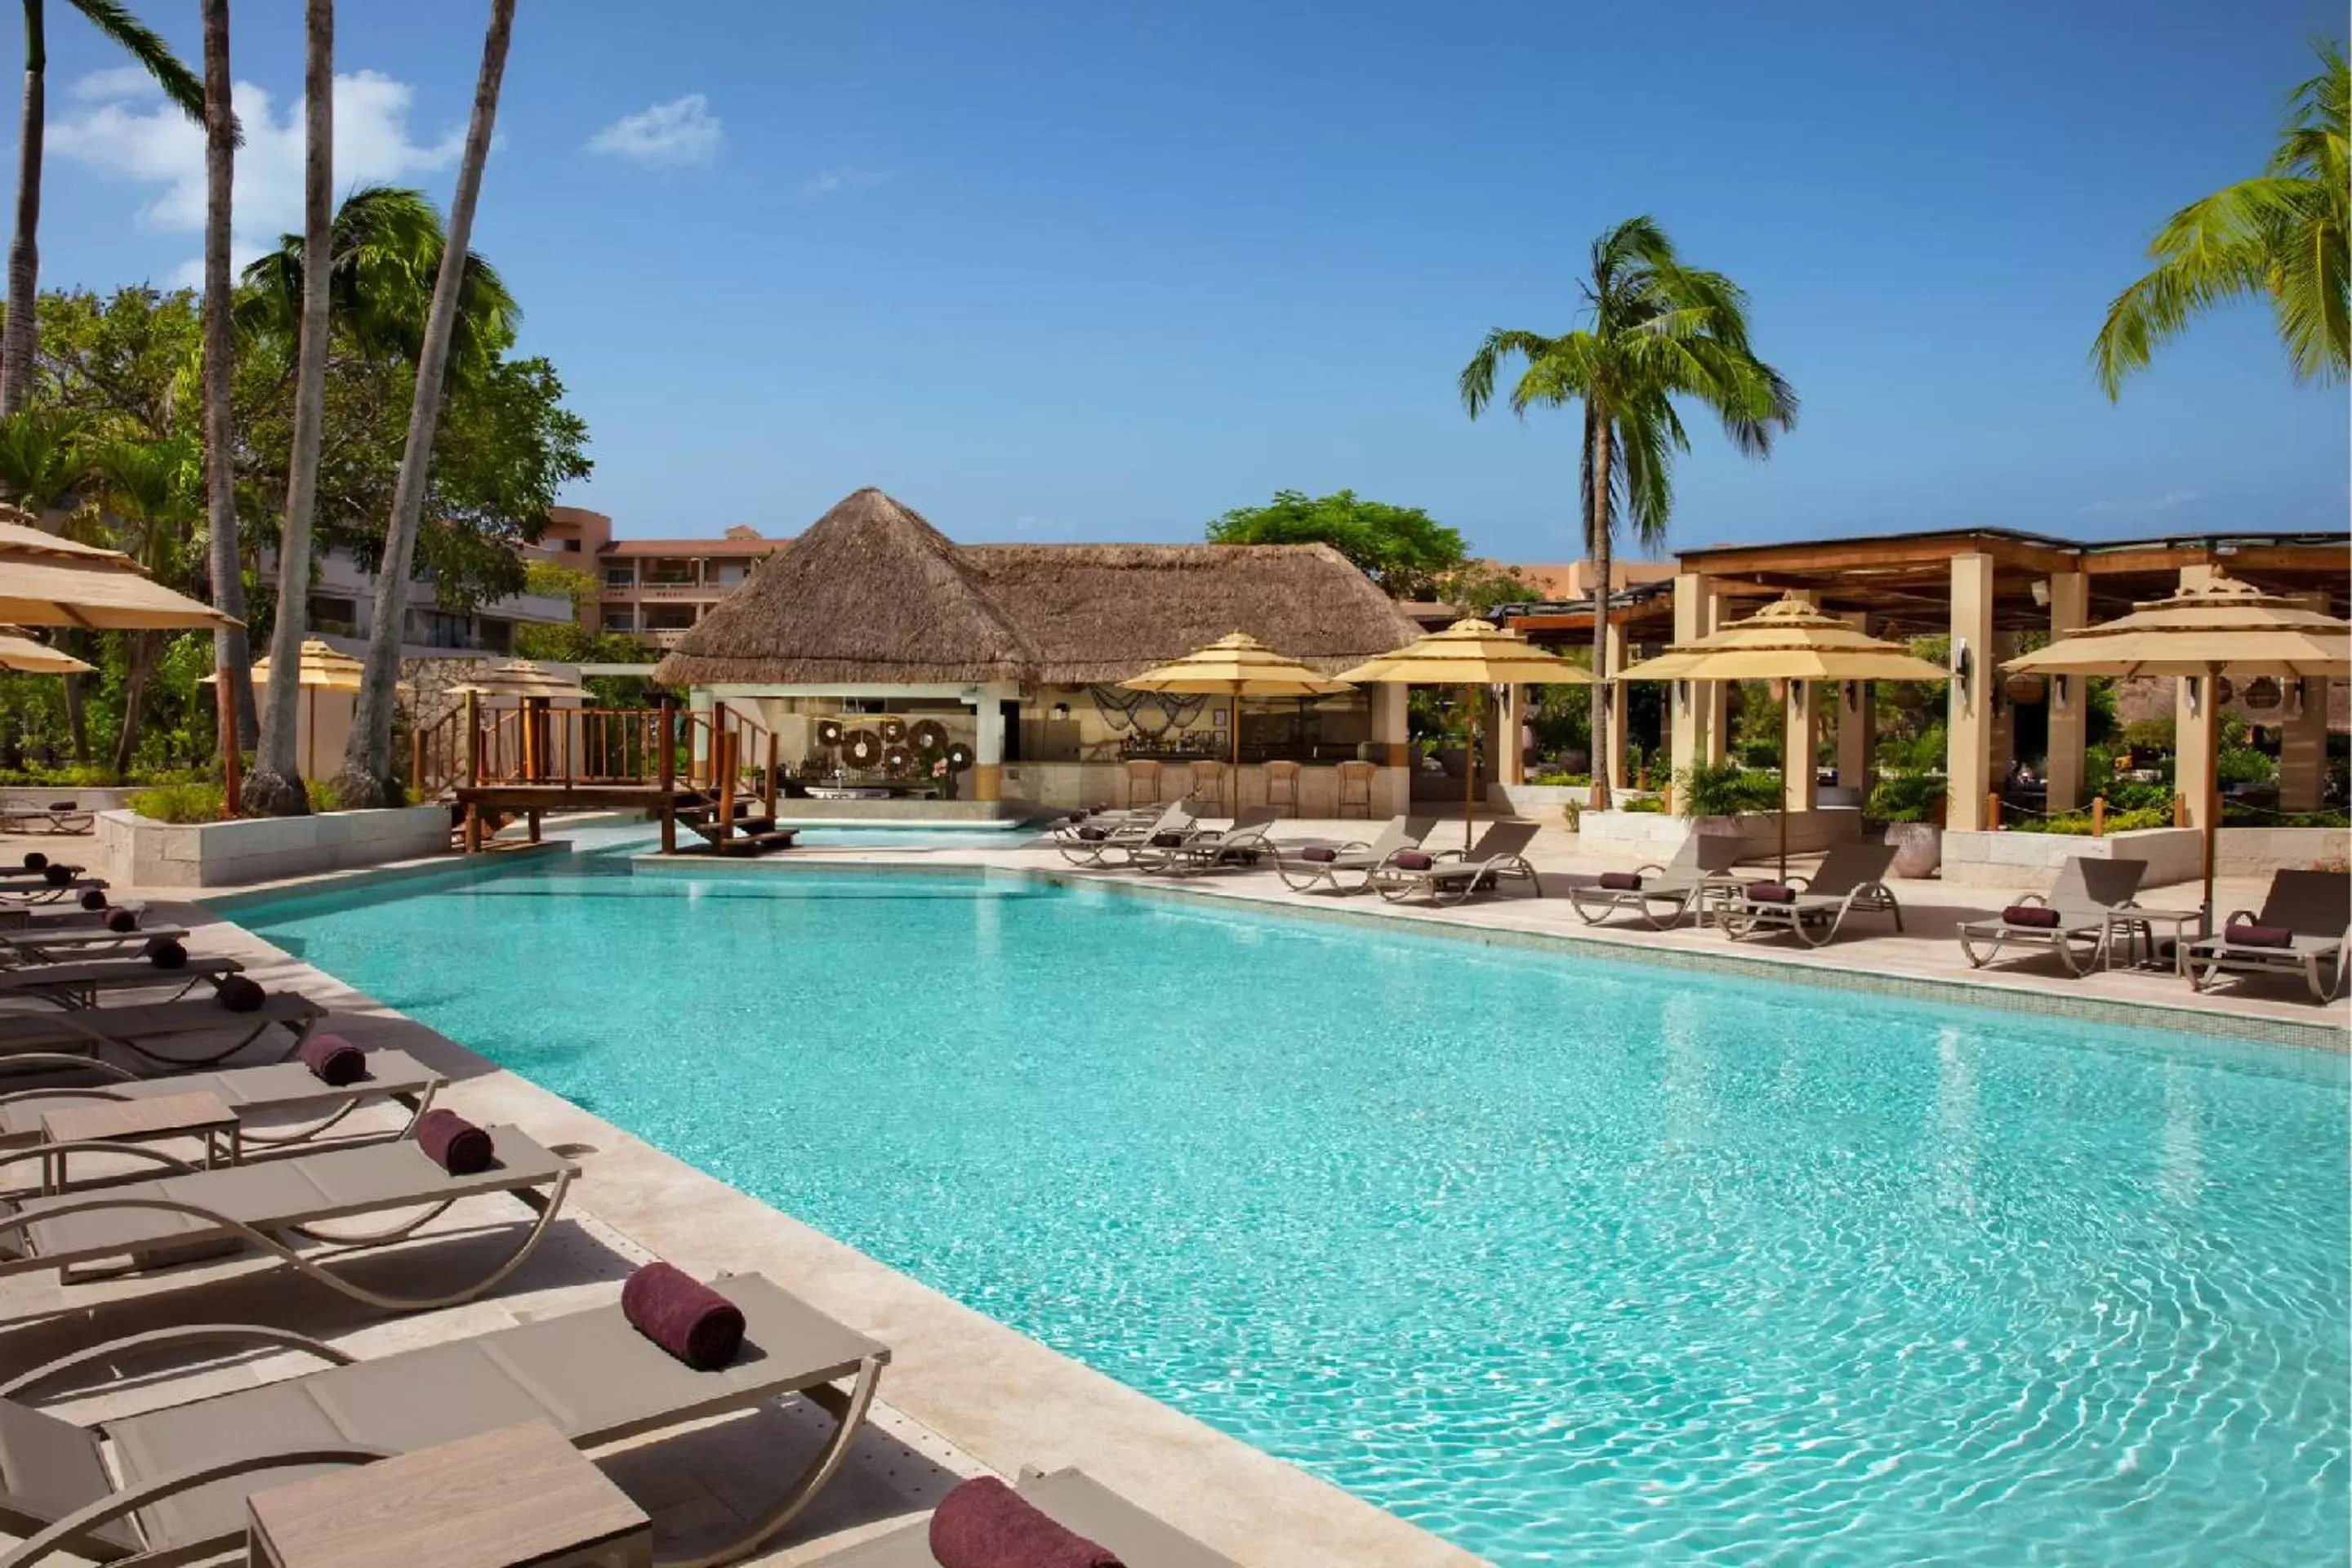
[0,1051,444,1159]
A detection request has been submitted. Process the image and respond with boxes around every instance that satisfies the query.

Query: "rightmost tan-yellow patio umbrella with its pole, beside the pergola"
[2002,576,2352,931]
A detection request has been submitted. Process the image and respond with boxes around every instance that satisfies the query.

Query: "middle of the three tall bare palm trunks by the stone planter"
[245,0,334,816]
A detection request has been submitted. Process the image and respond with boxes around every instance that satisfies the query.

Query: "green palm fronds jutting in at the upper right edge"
[2091,42,2352,397]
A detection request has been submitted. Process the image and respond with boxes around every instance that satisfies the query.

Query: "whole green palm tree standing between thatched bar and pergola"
[1460,216,1797,802]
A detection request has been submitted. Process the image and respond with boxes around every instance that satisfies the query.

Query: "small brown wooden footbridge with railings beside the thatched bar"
[409,693,795,856]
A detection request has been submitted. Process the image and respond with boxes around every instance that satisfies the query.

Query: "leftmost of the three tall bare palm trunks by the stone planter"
[199,0,254,790]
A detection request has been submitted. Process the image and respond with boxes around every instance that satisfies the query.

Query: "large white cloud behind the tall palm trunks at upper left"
[47,68,466,284]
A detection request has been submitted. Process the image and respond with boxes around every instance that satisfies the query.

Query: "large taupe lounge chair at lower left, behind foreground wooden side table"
[0,1274,889,1563]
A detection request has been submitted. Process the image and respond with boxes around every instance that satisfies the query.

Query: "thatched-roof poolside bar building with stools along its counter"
[654,489,1416,818]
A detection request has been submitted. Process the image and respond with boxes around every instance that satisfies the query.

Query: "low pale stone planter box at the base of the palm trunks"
[92,797,449,889]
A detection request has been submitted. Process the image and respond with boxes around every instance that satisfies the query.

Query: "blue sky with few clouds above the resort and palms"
[23,0,2347,559]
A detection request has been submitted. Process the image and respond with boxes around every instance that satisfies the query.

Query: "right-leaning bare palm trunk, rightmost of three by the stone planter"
[336,0,515,806]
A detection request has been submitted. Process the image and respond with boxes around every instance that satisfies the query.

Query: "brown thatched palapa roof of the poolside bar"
[654,489,1419,687]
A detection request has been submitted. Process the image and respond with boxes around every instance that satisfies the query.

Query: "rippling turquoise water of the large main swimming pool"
[238,858,2352,1568]
